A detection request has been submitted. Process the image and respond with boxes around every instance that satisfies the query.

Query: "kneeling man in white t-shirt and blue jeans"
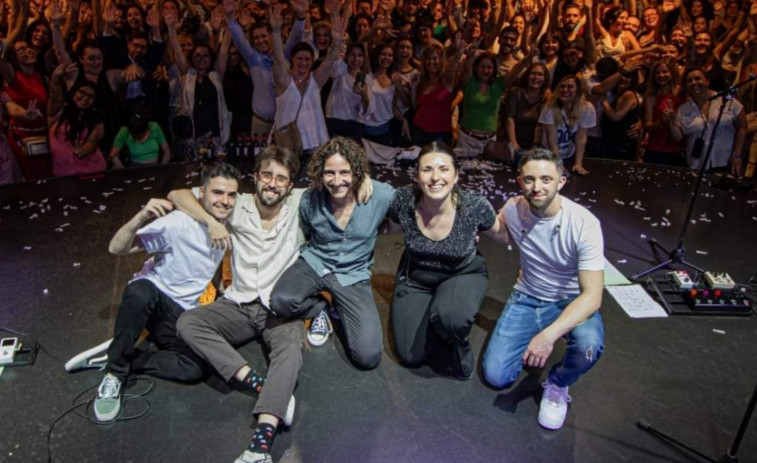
[483,149,604,429]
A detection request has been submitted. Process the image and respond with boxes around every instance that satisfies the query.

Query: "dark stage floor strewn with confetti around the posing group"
[0,161,757,463]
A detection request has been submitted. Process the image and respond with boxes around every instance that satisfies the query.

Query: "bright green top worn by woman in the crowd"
[460,76,505,132]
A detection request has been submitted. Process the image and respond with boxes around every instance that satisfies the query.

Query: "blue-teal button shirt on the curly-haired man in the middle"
[300,180,394,286]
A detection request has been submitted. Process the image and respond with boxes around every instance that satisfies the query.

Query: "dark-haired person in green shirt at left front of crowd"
[108,109,171,169]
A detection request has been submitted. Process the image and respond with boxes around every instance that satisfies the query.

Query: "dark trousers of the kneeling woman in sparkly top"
[391,254,488,378]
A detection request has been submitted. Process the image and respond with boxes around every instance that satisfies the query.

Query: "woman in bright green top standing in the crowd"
[455,47,505,157]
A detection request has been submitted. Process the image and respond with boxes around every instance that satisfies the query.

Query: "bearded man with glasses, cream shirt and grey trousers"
[168,146,305,463]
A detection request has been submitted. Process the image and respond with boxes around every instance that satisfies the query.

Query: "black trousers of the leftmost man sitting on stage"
[106,279,205,383]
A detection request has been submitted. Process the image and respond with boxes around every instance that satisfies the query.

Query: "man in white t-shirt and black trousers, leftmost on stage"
[66,163,240,422]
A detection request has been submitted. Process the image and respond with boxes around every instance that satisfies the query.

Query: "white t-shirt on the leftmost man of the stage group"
[132,211,225,310]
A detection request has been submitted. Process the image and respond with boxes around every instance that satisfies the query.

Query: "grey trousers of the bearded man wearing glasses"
[176,298,305,419]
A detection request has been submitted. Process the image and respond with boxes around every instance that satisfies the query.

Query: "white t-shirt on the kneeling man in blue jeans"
[500,196,605,301]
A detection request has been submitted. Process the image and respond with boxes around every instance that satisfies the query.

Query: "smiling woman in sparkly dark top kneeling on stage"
[388,142,506,380]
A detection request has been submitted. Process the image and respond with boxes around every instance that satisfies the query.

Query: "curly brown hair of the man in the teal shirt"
[308,137,371,194]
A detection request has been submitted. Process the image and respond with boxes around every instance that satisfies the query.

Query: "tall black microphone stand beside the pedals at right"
[631,74,757,281]
